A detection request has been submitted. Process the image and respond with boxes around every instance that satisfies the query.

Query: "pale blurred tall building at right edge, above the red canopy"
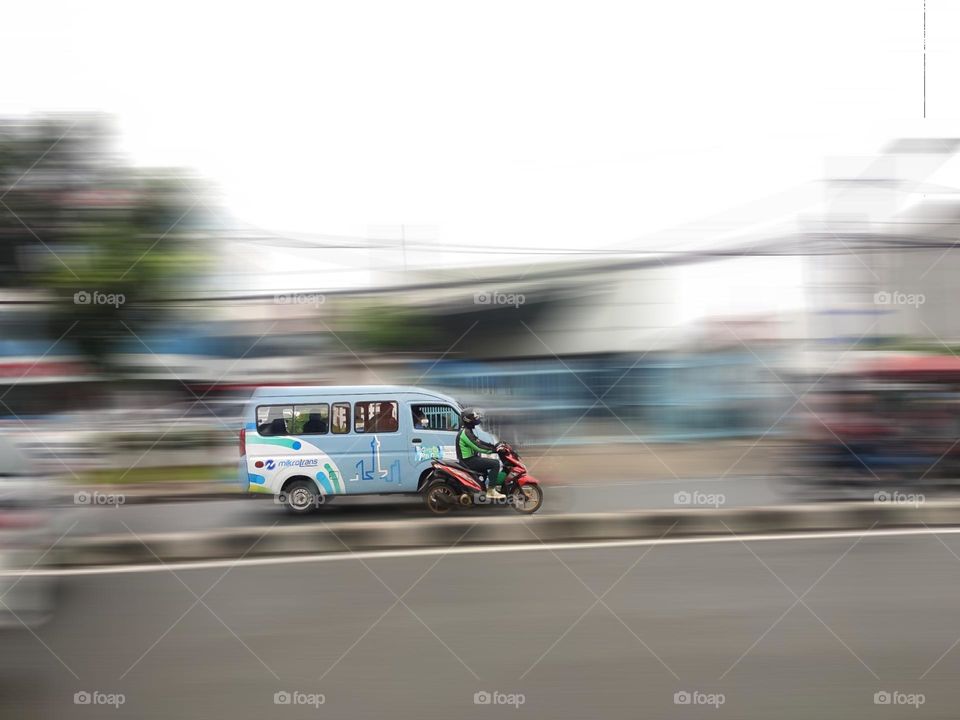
[808,139,960,352]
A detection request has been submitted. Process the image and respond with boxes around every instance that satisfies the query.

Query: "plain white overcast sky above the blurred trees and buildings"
[0,0,960,306]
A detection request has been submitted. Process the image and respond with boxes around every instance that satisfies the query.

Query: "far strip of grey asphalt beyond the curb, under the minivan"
[60,477,786,535]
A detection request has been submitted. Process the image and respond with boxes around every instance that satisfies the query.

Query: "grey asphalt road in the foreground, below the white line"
[0,535,960,720]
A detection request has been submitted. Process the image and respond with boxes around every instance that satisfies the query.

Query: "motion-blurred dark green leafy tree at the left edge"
[0,115,211,370]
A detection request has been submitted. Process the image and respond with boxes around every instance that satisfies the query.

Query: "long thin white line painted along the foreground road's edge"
[0,527,960,578]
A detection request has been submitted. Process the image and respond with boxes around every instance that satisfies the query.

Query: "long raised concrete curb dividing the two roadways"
[51,501,960,567]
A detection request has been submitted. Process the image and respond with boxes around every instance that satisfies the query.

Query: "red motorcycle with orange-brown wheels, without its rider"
[423,443,543,515]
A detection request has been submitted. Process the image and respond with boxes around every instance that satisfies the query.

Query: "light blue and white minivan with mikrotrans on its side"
[239,385,461,514]
